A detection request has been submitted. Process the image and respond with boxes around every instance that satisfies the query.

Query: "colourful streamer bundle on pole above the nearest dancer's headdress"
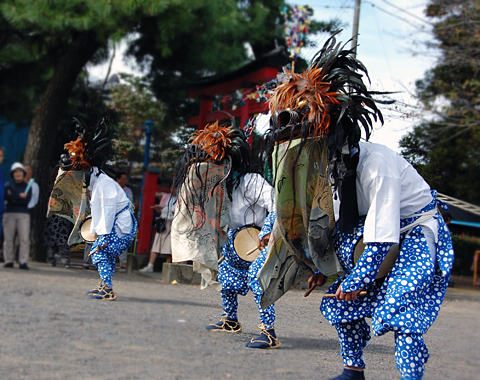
[280,5,313,61]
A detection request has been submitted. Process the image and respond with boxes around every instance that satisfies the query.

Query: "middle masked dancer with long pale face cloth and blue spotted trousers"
[172,122,280,348]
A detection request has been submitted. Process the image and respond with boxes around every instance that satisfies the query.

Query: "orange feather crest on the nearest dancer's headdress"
[269,65,340,136]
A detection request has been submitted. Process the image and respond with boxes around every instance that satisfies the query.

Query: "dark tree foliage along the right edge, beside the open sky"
[400,0,480,204]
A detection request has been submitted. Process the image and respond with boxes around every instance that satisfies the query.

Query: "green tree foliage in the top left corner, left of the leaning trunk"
[0,0,166,122]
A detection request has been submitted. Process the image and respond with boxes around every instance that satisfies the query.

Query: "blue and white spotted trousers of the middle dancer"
[218,212,275,328]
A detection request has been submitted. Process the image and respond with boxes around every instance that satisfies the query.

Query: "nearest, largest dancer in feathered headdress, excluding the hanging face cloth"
[260,36,453,380]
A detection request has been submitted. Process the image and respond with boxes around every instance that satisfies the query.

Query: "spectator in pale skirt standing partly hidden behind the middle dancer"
[140,185,177,273]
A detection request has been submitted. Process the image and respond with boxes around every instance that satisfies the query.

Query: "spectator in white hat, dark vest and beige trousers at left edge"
[3,162,32,269]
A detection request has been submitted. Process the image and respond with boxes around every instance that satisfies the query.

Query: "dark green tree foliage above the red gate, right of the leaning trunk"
[129,0,260,125]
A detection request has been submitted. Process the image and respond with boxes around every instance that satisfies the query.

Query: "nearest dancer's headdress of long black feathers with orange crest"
[265,33,392,231]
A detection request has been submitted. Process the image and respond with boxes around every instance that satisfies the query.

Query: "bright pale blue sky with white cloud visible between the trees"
[89,0,435,151]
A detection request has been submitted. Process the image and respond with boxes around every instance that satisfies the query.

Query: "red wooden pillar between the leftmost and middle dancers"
[137,170,158,255]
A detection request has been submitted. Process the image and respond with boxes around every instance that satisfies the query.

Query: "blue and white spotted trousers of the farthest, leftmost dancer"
[90,205,137,288]
